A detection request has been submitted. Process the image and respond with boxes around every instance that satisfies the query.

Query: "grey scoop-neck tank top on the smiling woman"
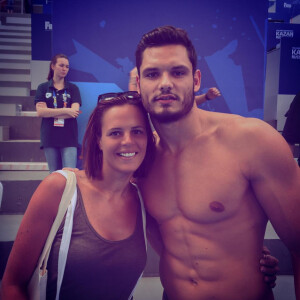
[47,187,147,300]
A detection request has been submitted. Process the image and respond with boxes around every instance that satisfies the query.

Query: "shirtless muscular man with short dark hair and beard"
[136,26,300,300]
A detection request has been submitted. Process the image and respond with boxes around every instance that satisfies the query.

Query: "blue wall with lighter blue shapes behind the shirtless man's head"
[52,0,268,141]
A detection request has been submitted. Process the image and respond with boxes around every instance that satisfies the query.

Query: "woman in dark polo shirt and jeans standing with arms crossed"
[34,54,81,173]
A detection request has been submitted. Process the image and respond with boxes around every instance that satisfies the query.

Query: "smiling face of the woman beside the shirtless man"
[99,104,147,175]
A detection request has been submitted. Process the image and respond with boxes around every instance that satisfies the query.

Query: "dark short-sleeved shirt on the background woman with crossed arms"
[34,79,81,148]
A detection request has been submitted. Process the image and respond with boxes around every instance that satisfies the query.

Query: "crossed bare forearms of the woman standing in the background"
[35,102,80,119]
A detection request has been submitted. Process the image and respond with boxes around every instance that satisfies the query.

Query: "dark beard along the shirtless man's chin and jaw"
[149,90,195,123]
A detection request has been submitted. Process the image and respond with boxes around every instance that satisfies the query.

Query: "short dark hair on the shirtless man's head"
[135,26,197,74]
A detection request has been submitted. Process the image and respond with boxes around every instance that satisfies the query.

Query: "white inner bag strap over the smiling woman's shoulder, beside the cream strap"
[55,170,77,300]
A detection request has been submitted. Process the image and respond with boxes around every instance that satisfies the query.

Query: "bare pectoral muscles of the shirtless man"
[142,149,252,223]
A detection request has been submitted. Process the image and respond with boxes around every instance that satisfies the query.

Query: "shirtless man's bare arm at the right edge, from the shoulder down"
[247,122,300,300]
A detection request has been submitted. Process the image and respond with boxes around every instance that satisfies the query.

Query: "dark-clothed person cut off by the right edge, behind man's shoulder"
[282,93,300,167]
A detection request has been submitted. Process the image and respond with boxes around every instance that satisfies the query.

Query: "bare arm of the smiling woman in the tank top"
[1,173,66,300]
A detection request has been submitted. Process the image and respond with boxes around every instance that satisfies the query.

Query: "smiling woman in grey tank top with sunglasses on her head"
[2,93,155,300]
